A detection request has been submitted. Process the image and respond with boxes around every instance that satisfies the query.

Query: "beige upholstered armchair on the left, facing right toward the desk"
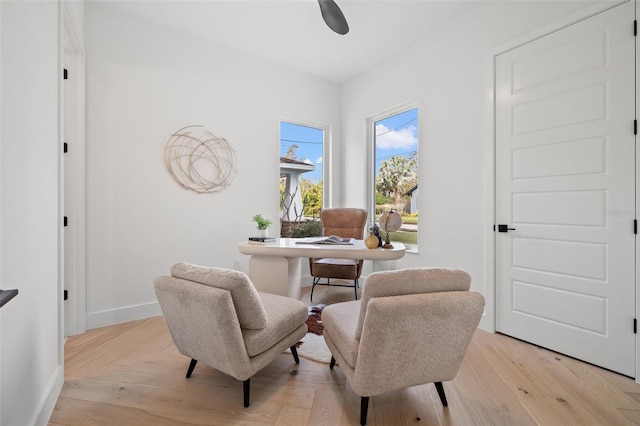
[154,263,308,407]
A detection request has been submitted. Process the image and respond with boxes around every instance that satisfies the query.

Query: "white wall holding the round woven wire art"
[84,2,340,328]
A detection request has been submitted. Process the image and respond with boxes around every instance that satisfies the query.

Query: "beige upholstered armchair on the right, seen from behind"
[322,268,484,425]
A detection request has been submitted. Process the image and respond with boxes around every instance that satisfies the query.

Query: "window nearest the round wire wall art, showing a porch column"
[280,121,327,237]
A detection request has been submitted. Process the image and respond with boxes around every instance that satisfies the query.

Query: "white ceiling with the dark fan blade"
[100,0,595,83]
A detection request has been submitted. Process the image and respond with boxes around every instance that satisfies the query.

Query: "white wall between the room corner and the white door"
[341,2,596,329]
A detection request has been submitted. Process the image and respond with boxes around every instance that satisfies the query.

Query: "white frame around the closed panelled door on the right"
[480,0,640,383]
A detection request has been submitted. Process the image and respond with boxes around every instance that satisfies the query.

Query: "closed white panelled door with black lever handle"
[495,2,636,376]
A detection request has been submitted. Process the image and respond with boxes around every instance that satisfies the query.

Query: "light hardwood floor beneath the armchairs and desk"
[49,289,640,426]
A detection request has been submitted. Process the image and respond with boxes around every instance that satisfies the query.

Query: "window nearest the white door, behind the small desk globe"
[371,108,418,250]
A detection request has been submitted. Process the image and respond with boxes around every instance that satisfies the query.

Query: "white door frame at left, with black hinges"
[59,2,86,336]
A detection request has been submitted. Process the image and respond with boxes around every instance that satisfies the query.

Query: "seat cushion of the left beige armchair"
[242,292,308,357]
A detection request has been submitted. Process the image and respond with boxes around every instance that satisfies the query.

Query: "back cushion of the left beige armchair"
[171,263,266,330]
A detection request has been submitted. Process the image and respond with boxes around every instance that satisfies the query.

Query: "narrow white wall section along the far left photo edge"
[0,1,63,425]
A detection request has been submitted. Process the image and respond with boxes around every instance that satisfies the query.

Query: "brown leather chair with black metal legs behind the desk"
[309,207,367,301]
